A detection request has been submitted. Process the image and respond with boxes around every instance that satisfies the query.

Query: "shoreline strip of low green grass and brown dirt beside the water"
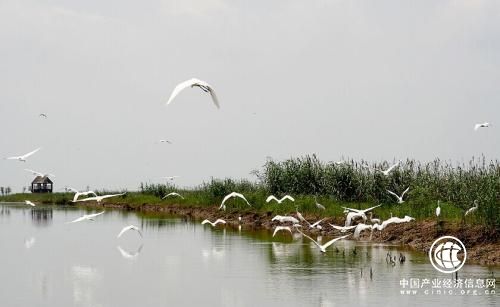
[0,191,500,265]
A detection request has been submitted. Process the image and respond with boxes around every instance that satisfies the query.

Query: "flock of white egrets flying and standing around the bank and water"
[5,78,490,258]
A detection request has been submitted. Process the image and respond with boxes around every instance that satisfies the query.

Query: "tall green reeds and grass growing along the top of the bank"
[0,155,500,229]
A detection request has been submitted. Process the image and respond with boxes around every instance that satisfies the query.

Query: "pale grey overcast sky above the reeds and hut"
[0,0,500,191]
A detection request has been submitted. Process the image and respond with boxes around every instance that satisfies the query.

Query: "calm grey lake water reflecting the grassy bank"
[0,204,500,307]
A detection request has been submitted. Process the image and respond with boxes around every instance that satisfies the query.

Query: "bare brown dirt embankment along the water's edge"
[87,203,500,265]
